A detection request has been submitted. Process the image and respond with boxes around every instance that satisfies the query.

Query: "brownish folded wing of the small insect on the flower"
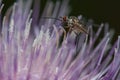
[73,24,88,34]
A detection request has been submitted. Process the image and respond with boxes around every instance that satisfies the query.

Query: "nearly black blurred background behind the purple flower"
[3,0,120,40]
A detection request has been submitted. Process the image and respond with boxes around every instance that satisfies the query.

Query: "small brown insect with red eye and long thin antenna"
[42,16,88,36]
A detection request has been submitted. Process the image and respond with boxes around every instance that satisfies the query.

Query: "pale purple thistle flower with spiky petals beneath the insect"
[0,0,120,80]
